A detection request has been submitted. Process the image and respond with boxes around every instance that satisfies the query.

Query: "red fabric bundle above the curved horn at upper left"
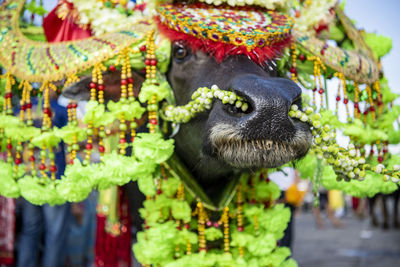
[43,1,91,43]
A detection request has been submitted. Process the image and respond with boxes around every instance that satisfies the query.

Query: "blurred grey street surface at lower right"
[293,210,400,267]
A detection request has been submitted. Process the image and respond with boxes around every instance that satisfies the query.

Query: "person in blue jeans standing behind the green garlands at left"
[17,92,70,267]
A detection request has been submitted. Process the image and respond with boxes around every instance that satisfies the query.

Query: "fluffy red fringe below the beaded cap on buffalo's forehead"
[155,17,291,66]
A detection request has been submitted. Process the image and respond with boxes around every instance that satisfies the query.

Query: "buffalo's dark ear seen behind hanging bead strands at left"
[62,71,144,102]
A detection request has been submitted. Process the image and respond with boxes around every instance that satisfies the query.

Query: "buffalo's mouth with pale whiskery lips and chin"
[209,120,312,169]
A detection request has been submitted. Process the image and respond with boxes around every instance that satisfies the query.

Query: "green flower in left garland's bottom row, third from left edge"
[57,159,93,202]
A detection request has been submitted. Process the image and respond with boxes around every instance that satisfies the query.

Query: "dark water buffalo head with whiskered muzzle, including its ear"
[64,41,311,195]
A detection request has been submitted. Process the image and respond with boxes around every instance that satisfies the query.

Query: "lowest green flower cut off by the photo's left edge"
[0,161,20,198]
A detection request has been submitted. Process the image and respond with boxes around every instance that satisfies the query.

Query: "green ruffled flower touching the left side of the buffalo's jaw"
[133,133,174,164]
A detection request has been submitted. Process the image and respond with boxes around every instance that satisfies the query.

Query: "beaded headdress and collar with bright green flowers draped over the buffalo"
[0,0,400,266]
